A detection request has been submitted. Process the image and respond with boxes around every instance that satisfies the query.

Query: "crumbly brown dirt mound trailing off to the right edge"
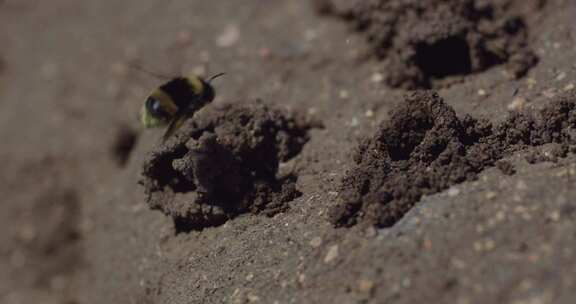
[331,91,576,227]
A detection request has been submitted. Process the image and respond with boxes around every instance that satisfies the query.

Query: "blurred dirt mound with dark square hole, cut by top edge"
[318,0,546,89]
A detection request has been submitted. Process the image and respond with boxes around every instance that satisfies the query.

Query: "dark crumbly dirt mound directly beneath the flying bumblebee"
[143,105,318,232]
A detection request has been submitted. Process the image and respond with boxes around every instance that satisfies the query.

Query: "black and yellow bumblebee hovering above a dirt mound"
[140,73,224,141]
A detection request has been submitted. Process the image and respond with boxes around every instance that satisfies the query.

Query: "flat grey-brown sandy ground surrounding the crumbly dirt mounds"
[0,0,576,304]
